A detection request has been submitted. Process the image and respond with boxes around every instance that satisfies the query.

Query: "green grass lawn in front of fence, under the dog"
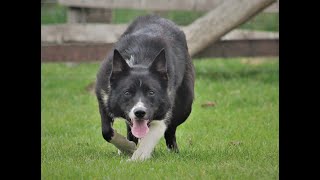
[41,58,279,179]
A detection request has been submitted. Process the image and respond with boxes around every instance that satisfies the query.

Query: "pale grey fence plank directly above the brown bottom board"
[41,24,279,44]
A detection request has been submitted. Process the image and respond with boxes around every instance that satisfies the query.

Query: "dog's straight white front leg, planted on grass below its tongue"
[130,121,167,161]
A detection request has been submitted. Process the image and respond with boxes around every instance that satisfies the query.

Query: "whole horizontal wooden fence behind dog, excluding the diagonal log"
[41,0,279,62]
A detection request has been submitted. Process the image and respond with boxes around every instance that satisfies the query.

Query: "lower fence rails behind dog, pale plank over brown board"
[41,24,279,62]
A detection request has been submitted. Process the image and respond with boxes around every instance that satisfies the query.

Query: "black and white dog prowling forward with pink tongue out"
[96,15,195,160]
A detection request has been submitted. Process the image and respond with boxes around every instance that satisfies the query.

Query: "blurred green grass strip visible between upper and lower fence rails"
[41,4,279,31]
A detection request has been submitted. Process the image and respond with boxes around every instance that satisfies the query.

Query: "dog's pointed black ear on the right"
[149,49,167,75]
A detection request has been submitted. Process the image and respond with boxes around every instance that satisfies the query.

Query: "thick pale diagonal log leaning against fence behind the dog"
[185,0,276,56]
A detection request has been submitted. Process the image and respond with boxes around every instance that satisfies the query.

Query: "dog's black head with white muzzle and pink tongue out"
[109,49,170,138]
